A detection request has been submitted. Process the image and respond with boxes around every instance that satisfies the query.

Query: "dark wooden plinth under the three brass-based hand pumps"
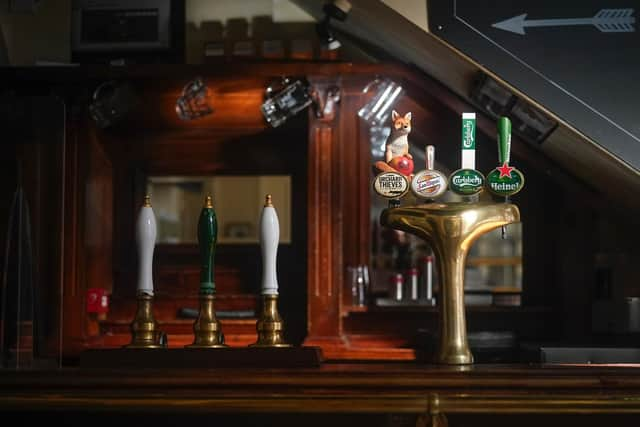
[80,346,323,369]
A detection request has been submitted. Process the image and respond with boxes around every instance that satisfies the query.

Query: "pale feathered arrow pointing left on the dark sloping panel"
[491,9,636,35]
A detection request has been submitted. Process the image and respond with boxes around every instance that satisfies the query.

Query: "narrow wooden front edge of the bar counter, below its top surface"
[0,392,640,414]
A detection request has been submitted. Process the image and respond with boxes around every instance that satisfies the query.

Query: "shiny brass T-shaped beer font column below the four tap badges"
[380,203,520,365]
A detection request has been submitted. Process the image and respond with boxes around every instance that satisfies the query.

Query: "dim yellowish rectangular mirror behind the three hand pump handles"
[147,175,291,244]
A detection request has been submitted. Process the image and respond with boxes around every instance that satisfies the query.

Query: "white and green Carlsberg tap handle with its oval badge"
[449,113,484,196]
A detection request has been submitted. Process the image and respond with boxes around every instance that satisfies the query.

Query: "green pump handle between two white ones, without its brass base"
[198,196,218,295]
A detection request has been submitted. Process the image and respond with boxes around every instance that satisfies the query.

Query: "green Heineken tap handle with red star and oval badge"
[487,117,524,197]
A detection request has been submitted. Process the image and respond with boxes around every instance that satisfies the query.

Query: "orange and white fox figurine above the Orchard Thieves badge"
[375,110,413,175]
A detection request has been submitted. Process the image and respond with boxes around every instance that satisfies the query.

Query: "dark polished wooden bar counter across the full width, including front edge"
[0,363,640,414]
